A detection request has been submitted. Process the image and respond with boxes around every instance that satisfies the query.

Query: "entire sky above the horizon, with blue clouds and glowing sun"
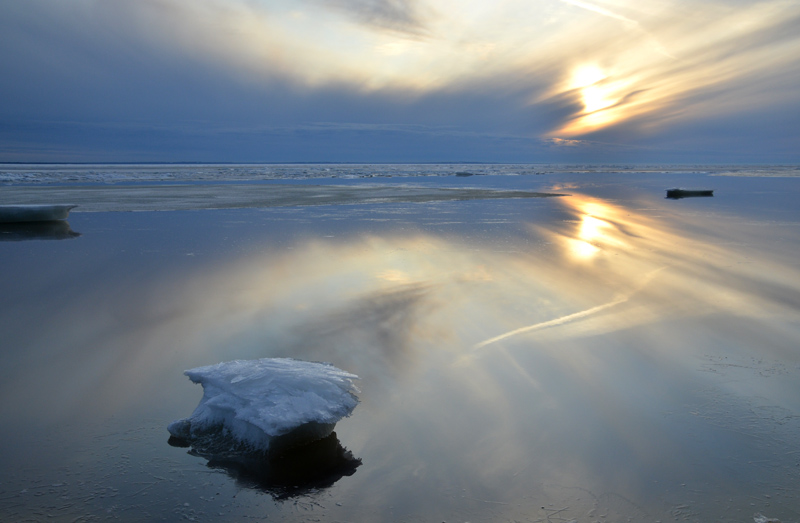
[0,0,800,163]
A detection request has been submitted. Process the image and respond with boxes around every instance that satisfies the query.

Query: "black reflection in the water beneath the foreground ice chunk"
[168,432,361,500]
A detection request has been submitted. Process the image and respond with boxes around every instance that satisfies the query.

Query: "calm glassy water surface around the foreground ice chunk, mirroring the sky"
[0,174,800,522]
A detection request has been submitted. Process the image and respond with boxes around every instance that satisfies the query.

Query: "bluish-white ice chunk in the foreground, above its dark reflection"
[168,358,358,451]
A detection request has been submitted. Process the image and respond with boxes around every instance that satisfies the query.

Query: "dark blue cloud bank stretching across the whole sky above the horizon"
[0,0,800,162]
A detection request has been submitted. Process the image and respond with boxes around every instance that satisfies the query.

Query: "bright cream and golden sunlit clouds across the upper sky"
[125,0,800,137]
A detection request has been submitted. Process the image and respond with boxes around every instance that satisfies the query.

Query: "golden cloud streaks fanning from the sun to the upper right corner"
[553,2,800,141]
